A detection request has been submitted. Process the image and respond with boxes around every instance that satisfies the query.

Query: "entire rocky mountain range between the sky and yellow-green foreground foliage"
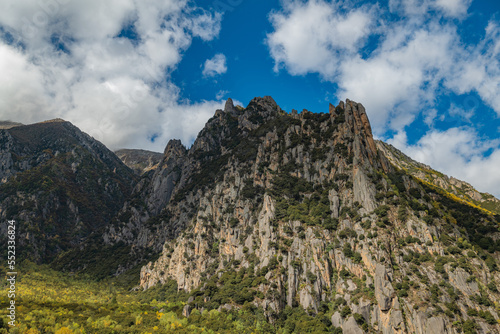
[0,97,500,334]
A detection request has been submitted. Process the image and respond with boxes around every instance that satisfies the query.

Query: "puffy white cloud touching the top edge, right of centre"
[266,0,374,78]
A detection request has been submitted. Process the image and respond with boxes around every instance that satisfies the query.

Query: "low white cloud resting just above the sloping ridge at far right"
[387,127,500,198]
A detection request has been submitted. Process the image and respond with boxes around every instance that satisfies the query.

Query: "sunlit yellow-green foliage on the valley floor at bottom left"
[0,264,266,334]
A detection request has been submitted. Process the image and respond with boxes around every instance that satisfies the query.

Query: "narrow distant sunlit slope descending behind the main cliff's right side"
[376,140,500,214]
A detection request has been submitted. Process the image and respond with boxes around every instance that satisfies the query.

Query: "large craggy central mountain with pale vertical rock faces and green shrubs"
[110,97,500,333]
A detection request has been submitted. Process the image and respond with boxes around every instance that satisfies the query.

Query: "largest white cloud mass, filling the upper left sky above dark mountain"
[0,0,223,151]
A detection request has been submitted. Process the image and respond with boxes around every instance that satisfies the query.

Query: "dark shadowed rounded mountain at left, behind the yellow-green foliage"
[0,119,136,262]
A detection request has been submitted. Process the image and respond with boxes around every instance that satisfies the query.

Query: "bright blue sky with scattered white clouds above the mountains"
[0,0,500,197]
